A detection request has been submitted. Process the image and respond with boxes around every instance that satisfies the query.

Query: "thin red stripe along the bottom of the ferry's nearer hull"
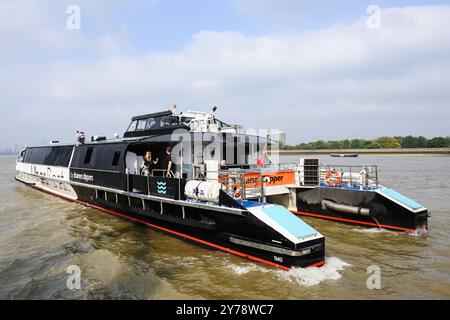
[31,185,325,271]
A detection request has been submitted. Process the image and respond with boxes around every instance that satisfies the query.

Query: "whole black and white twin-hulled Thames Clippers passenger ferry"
[16,108,428,270]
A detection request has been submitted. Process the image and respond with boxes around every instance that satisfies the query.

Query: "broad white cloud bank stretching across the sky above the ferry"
[0,6,450,148]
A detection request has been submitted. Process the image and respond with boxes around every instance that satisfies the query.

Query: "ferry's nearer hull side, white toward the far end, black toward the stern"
[16,163,325,269]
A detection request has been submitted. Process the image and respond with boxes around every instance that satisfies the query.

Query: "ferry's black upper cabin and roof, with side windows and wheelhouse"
[20,111,271,173]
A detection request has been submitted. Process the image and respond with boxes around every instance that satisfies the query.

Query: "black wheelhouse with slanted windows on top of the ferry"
[123,111,189,138]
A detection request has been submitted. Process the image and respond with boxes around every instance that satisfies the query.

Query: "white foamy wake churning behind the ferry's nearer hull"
[227,257,351,287]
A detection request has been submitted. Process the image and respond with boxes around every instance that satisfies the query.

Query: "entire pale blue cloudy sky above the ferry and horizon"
[0,0,450,148]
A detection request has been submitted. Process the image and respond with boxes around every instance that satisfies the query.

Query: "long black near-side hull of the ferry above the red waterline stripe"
[16,174,325,270]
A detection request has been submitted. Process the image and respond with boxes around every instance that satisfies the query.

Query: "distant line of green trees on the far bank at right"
[281,136,450,150]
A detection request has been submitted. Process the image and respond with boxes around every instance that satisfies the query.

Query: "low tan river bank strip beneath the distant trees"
[269,148,450,156]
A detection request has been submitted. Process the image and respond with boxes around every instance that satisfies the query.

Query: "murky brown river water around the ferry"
[0,156,450,299]
